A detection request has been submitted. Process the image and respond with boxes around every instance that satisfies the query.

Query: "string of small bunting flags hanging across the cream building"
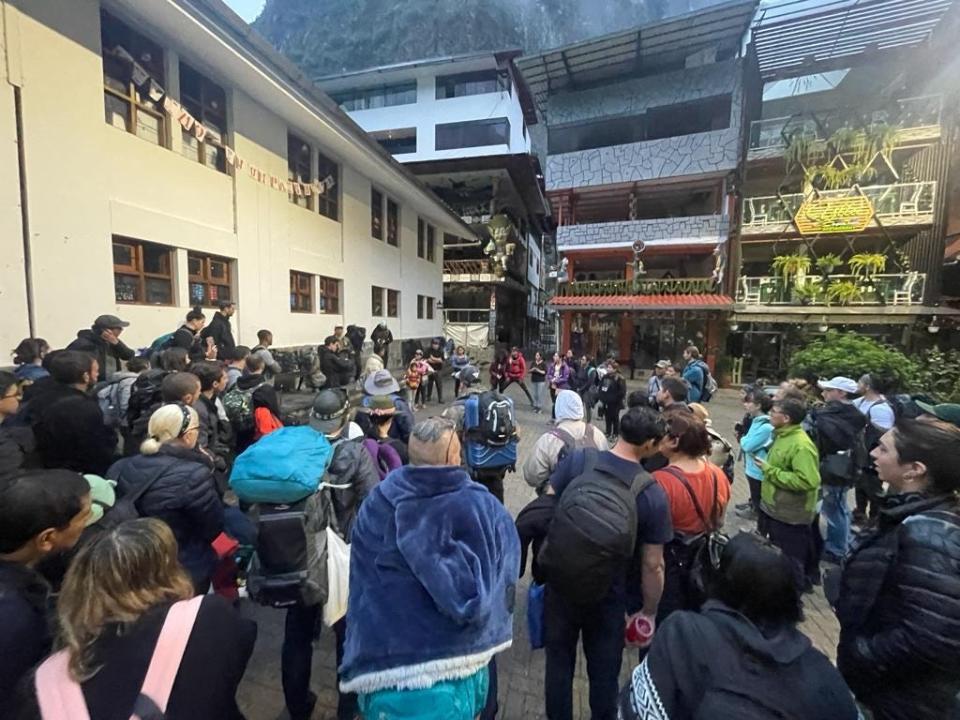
[113,45,337,197]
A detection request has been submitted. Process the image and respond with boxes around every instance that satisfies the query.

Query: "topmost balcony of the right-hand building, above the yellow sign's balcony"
[747,95,943,161]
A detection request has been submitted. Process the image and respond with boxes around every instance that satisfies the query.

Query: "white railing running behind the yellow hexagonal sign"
[743,181,937,227]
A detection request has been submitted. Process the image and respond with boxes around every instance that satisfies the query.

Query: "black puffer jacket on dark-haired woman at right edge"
[837,494,960,720]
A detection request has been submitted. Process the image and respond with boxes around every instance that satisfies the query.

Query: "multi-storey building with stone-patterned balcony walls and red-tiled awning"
[518,2,756,368]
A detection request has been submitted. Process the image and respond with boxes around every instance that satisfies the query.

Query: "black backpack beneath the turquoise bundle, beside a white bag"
[247,490,333,608]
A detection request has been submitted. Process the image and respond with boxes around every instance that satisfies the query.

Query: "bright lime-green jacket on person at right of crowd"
[760,425,820,525]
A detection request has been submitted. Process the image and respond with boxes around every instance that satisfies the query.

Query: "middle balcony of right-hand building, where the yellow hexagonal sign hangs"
[741,181,937,237]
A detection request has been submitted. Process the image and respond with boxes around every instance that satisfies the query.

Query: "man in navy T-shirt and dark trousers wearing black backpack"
[537,408,673,720]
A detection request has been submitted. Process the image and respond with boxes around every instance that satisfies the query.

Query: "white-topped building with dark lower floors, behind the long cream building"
[317,50,549,348]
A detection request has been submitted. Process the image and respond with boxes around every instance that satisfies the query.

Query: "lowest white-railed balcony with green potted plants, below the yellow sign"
[737,272,927,308]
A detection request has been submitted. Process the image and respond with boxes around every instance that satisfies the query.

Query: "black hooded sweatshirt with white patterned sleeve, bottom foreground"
[620,600,859,720]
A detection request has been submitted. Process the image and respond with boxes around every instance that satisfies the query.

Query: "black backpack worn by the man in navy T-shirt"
[537,450,654,605]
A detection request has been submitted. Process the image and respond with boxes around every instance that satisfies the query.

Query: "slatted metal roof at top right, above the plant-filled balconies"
[752,0,953,80]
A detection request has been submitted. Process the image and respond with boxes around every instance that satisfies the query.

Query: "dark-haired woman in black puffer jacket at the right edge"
[826,417,960,720]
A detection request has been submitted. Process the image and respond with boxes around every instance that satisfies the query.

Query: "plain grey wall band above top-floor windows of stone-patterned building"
[546,60,742,127]
